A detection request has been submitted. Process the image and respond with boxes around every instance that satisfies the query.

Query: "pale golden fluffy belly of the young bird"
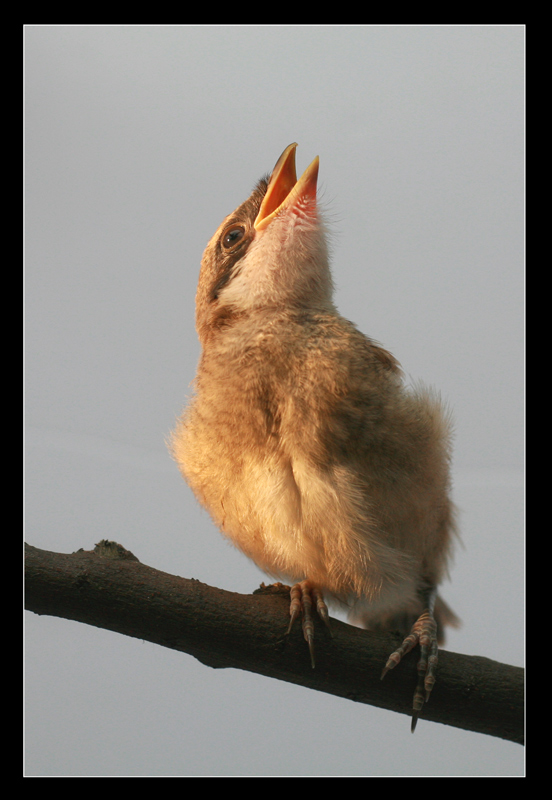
[177,418,414,604]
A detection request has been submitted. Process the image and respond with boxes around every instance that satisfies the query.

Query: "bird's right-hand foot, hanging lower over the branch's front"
[381,608,438,733]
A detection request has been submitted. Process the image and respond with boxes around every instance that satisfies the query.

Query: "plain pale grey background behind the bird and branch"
[25,25,525,777]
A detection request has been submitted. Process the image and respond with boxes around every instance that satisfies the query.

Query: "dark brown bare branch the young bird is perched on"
[26,542,524,743]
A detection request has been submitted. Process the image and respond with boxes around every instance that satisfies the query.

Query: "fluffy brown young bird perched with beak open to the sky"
[170,143,458,731]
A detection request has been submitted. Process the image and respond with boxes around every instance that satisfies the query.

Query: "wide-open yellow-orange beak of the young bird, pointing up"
[254,142,319,231]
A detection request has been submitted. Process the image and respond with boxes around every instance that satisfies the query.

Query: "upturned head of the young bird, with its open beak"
[196,144,333,341]
